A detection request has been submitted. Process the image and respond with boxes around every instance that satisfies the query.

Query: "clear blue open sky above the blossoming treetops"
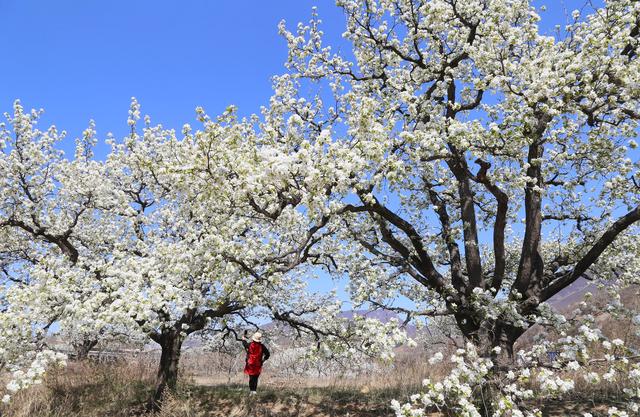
[0,0,584,158]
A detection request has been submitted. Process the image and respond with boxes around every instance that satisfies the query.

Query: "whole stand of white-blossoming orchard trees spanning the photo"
[0,0,640,417]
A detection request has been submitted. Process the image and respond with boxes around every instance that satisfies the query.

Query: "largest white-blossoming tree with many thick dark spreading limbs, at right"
[270,0,640,415]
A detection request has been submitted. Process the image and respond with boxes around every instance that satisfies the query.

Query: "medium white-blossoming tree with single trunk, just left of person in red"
[120,102,412,401]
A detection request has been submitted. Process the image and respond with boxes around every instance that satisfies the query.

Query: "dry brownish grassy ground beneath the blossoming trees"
[0,362,632,417]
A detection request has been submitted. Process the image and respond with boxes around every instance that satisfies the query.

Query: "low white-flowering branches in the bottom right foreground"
[392,314,640,417]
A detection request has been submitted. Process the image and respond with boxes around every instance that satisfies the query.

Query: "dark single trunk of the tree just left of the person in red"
[150,329,184,410]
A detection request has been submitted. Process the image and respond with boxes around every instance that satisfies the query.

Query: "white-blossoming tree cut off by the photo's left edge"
[0,102,120,399]
